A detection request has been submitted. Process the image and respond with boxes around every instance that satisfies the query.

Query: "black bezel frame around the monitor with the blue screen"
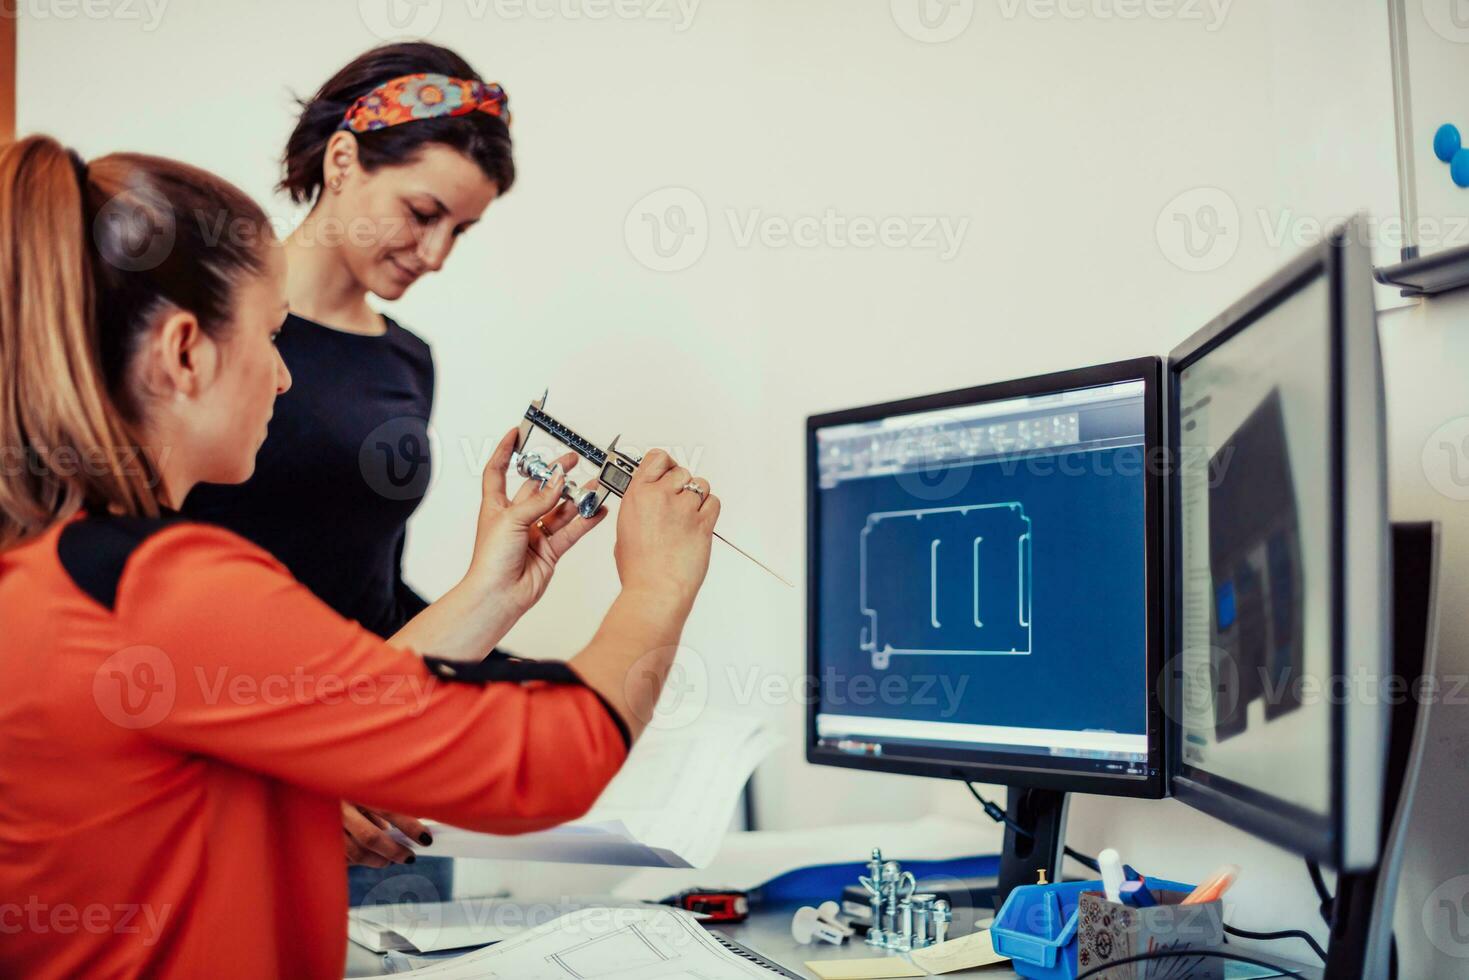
[806,357,1168,799]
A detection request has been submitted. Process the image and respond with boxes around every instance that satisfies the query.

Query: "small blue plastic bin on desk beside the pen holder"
[990,877,1194,980]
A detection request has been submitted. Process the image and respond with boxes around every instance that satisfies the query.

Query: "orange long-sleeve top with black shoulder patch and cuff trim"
[0,517,627,980]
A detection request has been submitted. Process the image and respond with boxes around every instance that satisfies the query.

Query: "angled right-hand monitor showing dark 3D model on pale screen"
[1165,222,1391,870]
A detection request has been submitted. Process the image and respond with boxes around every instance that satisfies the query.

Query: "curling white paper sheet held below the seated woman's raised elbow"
[414,708,780,868]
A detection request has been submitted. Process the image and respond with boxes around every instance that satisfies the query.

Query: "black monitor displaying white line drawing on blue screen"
[806,359,1165,799]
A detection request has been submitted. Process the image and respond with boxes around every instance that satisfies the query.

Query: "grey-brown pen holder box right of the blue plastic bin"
[1077,887,1224,980]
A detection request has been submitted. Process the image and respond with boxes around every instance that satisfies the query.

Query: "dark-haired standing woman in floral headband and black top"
[185,43,608,904]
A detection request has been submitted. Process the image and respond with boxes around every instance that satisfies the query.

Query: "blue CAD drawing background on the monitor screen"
[818,445,1147,733]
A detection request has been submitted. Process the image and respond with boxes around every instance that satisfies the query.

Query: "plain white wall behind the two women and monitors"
[19,0,1469,976]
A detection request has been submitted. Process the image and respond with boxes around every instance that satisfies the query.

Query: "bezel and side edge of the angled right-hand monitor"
[1165,222,1390,870]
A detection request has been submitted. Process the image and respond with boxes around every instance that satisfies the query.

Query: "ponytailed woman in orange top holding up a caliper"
[0,137,718,980]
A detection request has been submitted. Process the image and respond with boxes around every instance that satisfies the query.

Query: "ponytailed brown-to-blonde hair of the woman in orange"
[0,137,266,550]
